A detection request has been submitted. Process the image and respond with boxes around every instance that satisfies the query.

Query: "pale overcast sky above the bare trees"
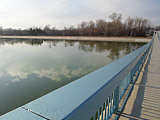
[0,0,160,29]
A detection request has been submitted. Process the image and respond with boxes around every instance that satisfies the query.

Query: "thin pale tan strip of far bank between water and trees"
[0,36,151,43]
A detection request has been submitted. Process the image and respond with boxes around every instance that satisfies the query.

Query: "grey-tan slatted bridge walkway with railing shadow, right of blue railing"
[120,33,160,120]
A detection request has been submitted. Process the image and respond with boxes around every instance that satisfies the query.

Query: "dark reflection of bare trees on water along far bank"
[0,39,144,60]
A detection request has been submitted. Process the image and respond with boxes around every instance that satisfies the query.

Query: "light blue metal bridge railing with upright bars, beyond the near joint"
[2,37,152,120]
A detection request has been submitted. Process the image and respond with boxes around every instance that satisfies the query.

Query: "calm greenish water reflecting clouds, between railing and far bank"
[0,39,143,115]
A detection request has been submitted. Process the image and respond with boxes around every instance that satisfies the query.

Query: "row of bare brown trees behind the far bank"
[0,13,160,36]
